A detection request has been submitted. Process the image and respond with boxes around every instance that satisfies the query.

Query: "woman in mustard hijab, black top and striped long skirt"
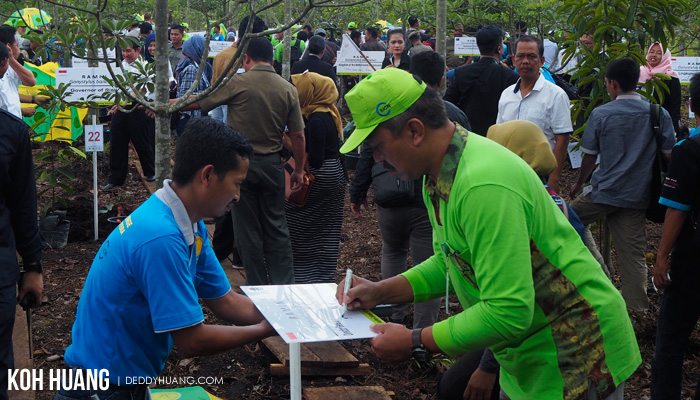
[284,72,345,283]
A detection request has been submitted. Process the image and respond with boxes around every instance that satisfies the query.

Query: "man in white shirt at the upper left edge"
[0,25,49,118]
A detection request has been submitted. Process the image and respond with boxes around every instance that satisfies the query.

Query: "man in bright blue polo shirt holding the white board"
[58,118,273,399]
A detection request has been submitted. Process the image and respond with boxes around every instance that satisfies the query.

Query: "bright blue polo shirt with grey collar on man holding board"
[65,186,231,385]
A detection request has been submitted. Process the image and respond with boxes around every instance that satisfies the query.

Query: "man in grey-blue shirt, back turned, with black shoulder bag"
[571,58,676,312]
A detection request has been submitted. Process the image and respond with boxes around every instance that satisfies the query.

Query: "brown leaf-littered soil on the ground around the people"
[26,144,700,400]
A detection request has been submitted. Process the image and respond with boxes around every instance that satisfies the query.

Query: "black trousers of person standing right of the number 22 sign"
[109,109,156,185]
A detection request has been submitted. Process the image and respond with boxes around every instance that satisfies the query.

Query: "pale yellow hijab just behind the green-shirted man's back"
[486,121,557,176]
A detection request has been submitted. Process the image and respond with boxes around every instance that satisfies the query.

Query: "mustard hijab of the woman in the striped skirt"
[292,71,345,141]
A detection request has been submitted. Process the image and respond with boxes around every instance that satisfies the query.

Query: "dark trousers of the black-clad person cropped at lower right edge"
[651,282,700,400]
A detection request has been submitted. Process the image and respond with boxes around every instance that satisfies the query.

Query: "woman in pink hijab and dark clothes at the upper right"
[639,42,681,136]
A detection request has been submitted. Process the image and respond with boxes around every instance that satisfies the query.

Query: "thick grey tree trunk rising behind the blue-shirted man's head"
[155,0,172,188]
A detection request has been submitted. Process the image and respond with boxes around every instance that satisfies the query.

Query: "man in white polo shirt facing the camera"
[496,35,573,192]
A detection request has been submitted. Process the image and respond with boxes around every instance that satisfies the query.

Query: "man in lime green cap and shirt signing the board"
[337,68,641,400]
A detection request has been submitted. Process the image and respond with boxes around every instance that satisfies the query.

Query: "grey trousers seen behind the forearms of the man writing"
[377,206,440,328]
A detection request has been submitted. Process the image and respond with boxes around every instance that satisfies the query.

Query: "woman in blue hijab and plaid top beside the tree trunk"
[175,35,212,135]
